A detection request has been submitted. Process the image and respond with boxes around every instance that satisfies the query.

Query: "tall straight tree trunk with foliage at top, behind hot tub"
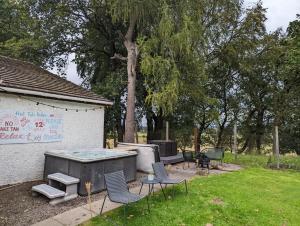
[108,0,157,143]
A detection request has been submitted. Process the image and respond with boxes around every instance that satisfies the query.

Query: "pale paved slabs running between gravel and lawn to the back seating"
[34,163,241,226]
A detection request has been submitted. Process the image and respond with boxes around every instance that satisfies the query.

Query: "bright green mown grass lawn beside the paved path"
[84,168,300,226]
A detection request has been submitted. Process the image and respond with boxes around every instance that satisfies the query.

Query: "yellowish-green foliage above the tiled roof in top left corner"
[0,0,49,66]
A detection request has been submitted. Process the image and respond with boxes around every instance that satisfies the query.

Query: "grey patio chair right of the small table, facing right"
[152,162,188,196]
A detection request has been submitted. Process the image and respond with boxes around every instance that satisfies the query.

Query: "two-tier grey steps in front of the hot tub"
[31,173,79,205]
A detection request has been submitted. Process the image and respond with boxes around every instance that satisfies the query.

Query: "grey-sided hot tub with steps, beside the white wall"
[44,148,137,195]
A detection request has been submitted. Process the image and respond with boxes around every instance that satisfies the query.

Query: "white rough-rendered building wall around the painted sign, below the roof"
[0,93,104,186]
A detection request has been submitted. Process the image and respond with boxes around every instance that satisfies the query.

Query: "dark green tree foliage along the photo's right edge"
[279,15,300,154]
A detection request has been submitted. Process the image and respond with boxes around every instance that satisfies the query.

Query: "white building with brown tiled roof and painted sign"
[0,56,112,186]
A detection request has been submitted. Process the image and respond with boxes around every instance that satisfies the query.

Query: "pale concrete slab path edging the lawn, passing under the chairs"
[33,164,240,226]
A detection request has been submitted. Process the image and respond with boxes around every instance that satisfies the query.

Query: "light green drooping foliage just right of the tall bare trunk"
[139,1,204,114]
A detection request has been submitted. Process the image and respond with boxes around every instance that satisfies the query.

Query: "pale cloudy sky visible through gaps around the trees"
[63,0,300,85]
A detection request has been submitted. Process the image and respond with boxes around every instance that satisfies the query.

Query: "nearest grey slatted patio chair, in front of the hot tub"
[100,171,150,218]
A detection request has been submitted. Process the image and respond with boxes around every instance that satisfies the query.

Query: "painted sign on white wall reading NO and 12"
[0,110,63,144]
